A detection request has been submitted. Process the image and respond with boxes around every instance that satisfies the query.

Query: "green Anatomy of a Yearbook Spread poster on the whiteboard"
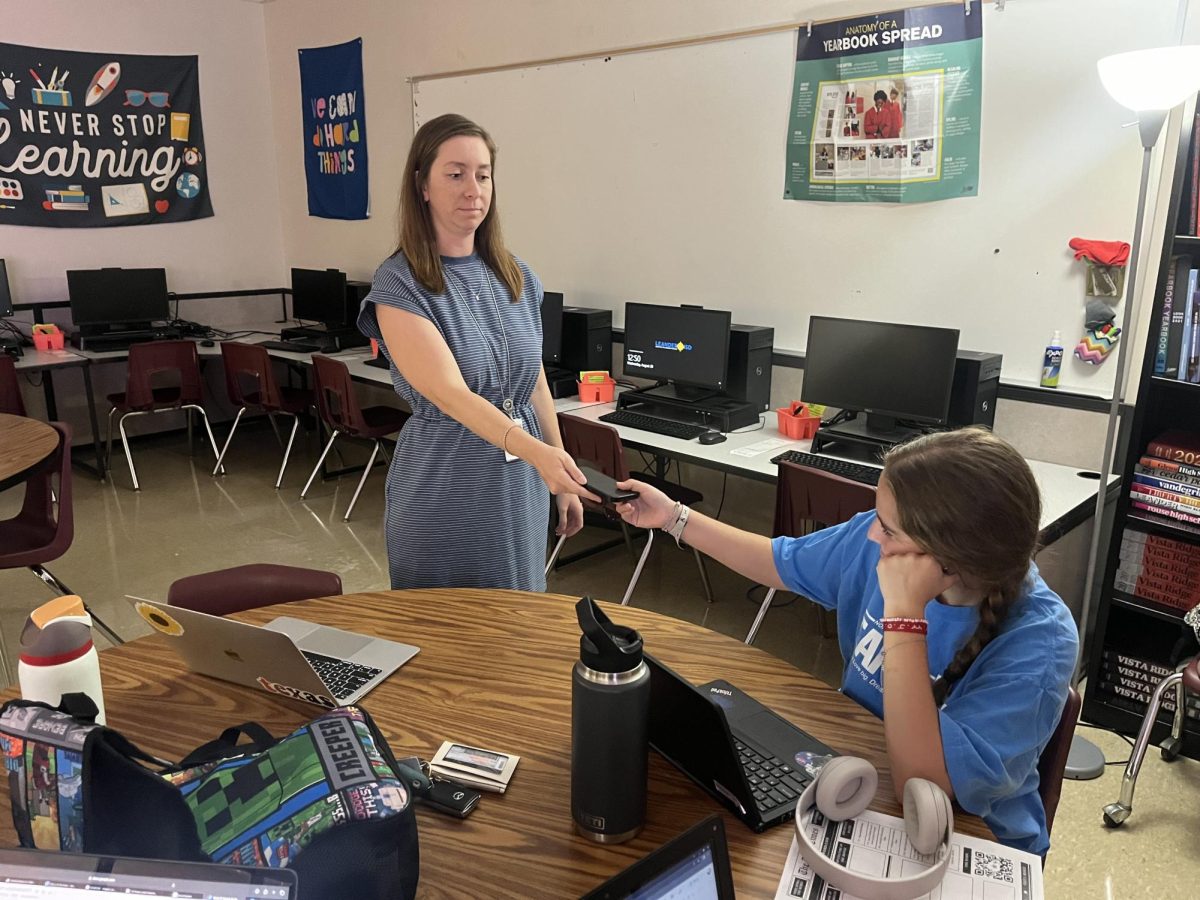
[784,2,983,203]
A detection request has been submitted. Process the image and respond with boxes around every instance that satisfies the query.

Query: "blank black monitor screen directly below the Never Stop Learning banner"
[67,269,170,325]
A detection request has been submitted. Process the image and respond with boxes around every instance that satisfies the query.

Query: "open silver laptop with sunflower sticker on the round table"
[125,595,420,708]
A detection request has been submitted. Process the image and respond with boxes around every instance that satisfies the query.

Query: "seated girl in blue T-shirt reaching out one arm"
[617,428,1079,854]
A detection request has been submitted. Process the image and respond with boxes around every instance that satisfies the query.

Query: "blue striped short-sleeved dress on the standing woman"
[358,253,550,590]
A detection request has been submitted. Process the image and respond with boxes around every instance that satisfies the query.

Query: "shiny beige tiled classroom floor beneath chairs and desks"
[0,426,1200,898]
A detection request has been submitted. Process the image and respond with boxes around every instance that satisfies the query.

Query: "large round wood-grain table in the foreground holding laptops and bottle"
[0,589,991,899]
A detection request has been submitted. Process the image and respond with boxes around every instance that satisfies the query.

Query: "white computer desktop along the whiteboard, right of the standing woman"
[559,401,1120,546]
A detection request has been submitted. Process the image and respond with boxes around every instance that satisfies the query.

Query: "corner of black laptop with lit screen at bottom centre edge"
[582,816,734,900]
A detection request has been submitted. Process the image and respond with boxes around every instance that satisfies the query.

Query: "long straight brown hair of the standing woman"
[396,113,524,302]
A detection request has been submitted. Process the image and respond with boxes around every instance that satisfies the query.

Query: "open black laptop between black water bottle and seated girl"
[644,653,838,832]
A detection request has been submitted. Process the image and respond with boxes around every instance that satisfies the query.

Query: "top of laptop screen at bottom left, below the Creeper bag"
[0,848,299,900]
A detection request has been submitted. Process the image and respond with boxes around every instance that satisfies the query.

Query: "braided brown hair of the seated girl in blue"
[883,428,1042,703]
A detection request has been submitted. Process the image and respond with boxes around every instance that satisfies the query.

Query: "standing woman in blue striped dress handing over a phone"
[359,115,587,590]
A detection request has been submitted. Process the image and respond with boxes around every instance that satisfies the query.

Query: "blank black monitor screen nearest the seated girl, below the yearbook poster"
[800,316,959,425]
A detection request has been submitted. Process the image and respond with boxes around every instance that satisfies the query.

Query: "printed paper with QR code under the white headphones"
[775,810,1043,900]
